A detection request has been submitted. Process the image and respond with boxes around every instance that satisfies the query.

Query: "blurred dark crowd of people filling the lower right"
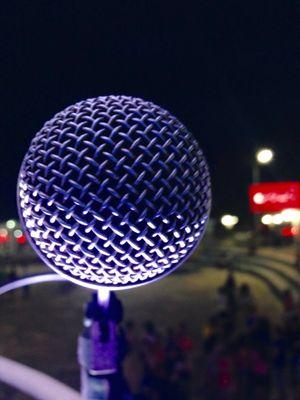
[123,273,300,400]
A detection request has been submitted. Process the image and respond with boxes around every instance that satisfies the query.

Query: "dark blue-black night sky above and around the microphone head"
[0,0,300,220]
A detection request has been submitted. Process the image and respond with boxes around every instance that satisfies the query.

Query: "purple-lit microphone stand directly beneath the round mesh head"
[78,289,129,400]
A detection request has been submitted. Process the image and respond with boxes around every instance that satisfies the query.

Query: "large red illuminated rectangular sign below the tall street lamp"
[249,182,300,214]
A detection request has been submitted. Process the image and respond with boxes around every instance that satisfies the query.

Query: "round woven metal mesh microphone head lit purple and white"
[17,96,211,289]
